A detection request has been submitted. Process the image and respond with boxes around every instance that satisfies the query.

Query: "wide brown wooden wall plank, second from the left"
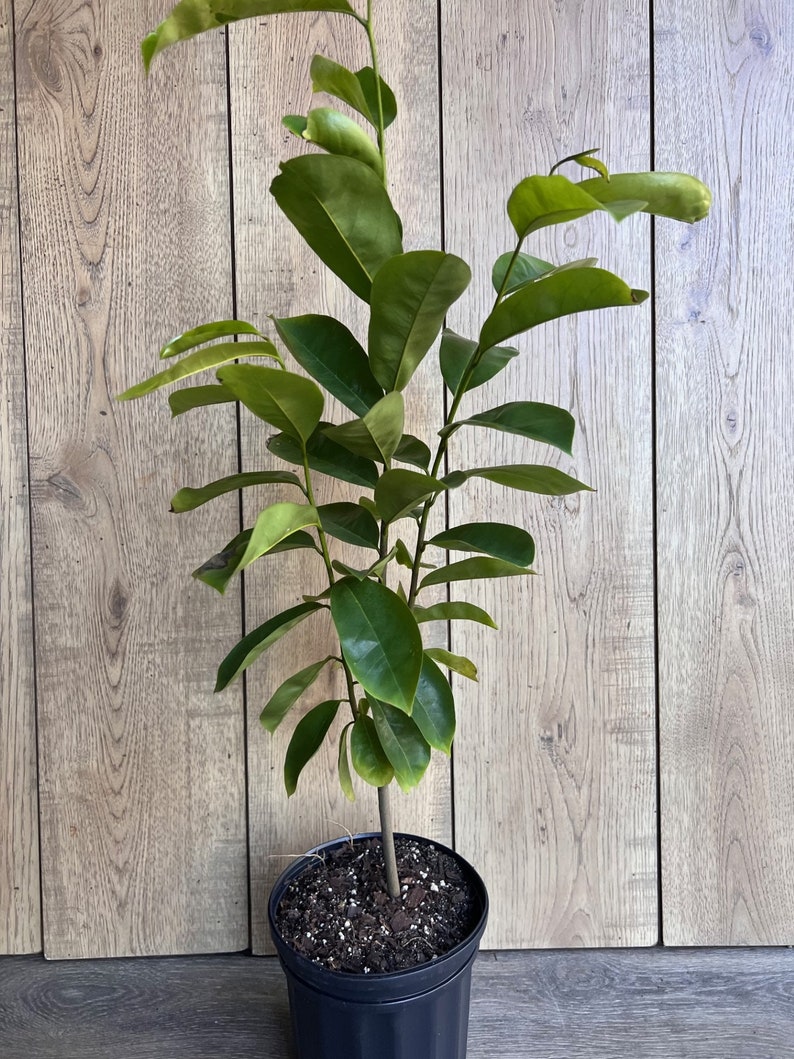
[15,0,248,956]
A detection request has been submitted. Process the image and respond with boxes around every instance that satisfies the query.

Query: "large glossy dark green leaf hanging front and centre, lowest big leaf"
[330,578,422,712]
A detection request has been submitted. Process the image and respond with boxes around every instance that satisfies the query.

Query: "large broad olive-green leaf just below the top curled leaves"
[270,155,402,302]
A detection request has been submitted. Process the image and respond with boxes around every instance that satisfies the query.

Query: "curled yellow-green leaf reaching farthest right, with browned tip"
[578,173,711,223]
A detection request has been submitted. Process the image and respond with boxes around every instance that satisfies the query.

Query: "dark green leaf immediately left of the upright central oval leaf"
[273,315,383,415]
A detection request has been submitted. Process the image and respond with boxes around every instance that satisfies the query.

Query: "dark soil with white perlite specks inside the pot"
[276,837,481,974]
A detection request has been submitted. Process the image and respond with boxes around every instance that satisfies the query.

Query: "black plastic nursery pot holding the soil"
[268,834,488,1059]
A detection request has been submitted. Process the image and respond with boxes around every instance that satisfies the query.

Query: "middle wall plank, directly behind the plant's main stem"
[230,6,451,951]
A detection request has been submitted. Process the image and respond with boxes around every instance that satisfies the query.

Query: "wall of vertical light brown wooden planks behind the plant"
[0,0,794,957]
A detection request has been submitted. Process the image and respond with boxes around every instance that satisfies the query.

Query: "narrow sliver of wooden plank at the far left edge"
[0,0,41,953]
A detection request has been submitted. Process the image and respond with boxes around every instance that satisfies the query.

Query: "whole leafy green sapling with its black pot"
[122,0,710,1059]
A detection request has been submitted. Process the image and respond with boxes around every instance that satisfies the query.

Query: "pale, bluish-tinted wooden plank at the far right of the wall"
[654,0,794,945]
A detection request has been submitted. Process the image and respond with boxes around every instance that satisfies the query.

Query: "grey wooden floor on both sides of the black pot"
[0,949,794,1059]
